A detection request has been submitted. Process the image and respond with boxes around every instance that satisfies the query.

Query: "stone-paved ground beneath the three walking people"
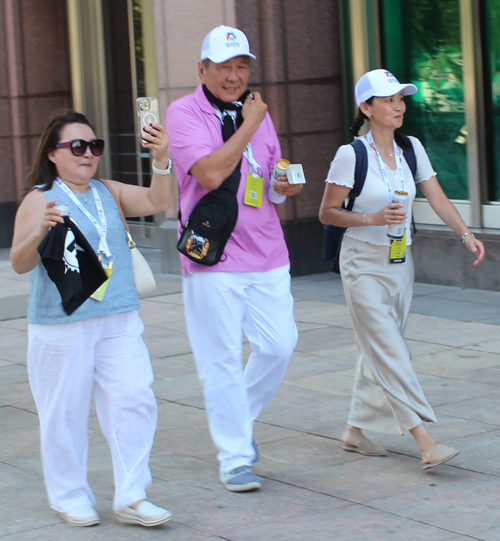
[0,246,500,541]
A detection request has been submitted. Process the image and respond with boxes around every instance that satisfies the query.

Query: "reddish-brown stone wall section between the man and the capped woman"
[236,0,346,275]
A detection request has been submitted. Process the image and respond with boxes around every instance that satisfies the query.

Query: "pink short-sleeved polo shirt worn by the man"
[165,85,289,276]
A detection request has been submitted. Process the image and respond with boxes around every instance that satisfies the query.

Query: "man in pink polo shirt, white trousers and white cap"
[166,26,302,492]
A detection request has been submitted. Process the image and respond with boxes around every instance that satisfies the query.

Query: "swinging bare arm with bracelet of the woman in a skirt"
[419,176,486,265]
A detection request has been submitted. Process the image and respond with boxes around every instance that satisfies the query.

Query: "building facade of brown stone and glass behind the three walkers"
[0,0,500,290]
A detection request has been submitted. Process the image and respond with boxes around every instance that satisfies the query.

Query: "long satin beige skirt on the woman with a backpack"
[340,237,436,434]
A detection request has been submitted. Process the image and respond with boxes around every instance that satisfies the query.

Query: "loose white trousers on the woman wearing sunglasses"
[28,311,157,512]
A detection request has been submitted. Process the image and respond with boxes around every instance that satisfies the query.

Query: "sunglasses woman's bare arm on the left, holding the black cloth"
[10,190,64,274]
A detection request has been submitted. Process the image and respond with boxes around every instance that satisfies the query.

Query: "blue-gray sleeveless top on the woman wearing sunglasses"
[28,180,140,323]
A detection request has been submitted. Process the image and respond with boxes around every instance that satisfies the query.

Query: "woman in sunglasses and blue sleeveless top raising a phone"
[10,111,172,526]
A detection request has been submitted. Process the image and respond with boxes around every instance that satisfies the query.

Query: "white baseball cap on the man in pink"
[201,25,255,64]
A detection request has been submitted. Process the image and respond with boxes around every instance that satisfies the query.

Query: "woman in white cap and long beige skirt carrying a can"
[320,69,485,469]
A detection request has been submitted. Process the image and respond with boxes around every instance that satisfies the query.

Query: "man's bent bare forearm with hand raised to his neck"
[190,92,267,190]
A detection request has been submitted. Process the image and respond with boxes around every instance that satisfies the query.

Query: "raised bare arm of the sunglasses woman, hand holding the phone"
[108,124,173,216]
